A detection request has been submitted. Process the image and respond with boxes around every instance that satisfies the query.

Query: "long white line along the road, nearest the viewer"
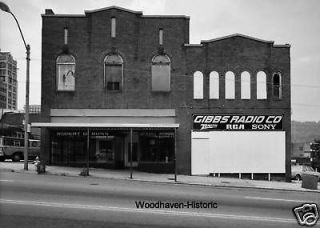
[0,199,296,223]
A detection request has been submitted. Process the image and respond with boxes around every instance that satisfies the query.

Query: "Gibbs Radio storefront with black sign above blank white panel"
[191,114,286,177]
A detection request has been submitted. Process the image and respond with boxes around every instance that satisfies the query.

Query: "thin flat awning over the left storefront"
[31,123,179,129]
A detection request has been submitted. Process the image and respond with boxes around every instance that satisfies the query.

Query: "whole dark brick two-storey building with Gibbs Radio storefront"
[32,6,291,180]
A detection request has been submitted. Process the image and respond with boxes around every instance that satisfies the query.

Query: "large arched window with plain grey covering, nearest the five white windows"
[151,55,171,92]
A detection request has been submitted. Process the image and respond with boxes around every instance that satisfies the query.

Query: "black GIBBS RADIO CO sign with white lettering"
[192,114,283,131]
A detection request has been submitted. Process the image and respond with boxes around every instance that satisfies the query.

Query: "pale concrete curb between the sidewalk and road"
[0,168,320,193]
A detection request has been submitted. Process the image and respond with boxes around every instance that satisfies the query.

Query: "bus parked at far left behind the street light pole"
[0,136,40,162]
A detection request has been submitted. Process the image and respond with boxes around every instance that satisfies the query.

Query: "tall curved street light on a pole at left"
[0,2,30,170]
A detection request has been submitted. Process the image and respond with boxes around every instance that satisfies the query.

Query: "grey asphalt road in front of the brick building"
[0,172,320,228]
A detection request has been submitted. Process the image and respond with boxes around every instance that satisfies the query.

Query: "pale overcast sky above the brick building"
[0,0,320,121]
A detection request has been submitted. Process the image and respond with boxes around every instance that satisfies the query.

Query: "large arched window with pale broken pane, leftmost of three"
[56,54,76,91]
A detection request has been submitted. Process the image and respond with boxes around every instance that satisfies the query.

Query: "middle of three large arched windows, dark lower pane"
[104,54,123,91]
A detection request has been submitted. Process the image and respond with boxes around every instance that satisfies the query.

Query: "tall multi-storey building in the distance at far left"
[0,52,18,110]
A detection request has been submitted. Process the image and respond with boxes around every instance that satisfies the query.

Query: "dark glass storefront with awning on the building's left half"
[33,123,179,172]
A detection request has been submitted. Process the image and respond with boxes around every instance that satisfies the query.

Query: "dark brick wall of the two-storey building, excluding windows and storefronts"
[42,8,291,178]
